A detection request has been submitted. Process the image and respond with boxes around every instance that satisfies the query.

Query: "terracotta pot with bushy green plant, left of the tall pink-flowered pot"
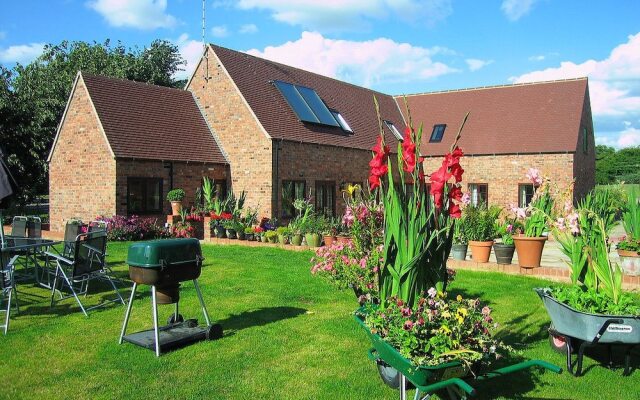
[464,204,500,263]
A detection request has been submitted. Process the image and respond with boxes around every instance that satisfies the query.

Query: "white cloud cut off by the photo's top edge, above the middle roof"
[237,0,452,31]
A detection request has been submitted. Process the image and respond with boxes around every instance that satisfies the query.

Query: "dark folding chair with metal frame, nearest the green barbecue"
[46,231,125,316]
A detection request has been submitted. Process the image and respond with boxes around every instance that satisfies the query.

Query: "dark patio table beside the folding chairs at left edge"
[2,236,62,289]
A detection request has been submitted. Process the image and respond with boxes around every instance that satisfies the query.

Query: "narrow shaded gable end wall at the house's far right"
[573,88,596,200]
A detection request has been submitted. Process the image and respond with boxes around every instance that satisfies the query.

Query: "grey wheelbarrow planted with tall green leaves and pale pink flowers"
[536,196,640,376]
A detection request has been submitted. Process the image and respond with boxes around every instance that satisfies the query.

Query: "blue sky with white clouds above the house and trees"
[0,0,640,147]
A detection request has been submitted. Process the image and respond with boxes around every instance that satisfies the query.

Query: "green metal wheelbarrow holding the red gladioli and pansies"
[355,315,562,400]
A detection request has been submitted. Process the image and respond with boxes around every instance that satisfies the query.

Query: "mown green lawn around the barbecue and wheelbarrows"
[0,243,640,400]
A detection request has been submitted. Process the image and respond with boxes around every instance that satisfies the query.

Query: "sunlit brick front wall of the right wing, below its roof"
[425,149,573,207]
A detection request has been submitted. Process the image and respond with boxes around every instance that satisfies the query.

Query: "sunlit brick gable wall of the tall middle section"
[187,49,273,220]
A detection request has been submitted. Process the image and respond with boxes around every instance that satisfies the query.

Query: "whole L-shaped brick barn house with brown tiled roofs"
[49,45,595,230]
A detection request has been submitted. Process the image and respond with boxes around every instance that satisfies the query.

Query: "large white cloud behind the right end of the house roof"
[510,33,640,146]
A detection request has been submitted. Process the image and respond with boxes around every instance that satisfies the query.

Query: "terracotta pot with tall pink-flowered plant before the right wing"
[512,168,554,268]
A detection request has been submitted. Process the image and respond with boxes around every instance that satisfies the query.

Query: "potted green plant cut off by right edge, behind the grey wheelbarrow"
[616,187,640,275]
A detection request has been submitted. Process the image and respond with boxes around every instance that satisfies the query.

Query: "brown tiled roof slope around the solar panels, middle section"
[211,45,404,150]
